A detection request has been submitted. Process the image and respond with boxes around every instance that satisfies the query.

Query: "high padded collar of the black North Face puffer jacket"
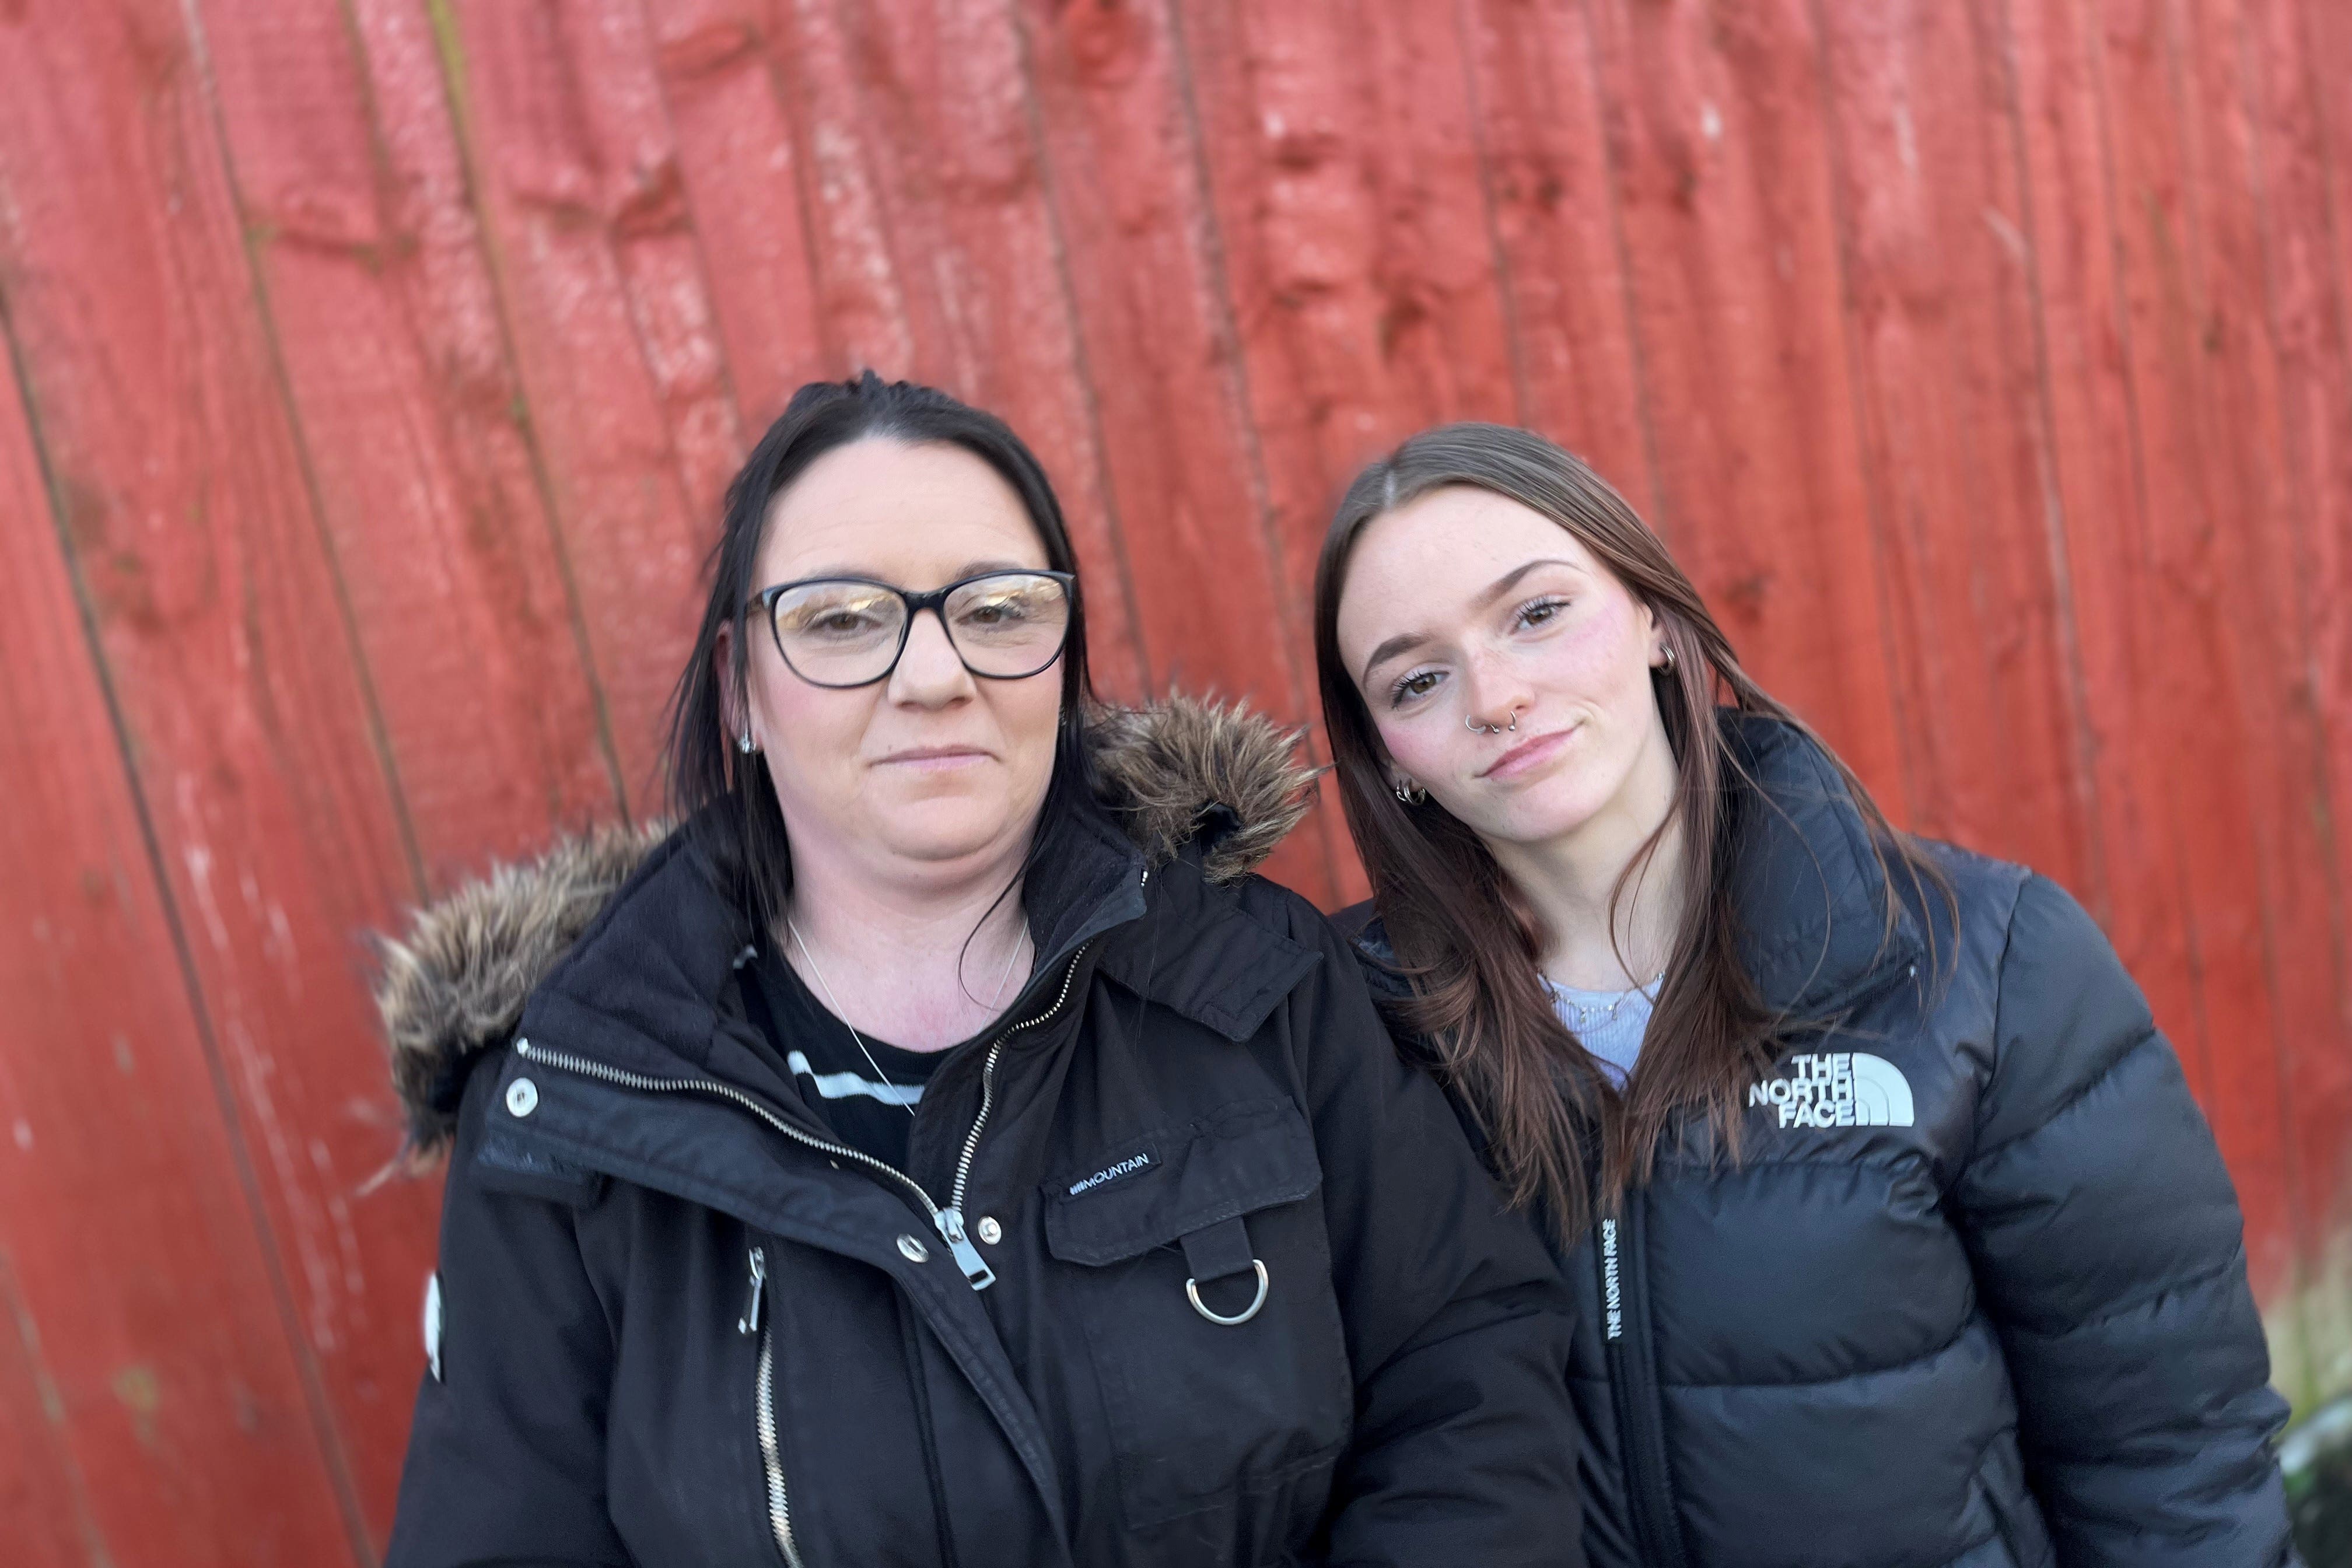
[1354,708,1924,1023]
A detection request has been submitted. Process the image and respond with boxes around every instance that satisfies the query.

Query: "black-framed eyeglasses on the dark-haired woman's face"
[746,571,1077,687]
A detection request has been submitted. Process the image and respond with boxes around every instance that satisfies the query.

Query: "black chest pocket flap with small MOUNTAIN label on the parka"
[1044,1098,1322,1267]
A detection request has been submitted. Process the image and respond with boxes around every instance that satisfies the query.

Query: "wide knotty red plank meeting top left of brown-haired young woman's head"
[1174,0,1520,606]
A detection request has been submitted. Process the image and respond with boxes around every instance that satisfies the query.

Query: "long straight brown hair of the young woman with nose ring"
[1315,423,1943,1244]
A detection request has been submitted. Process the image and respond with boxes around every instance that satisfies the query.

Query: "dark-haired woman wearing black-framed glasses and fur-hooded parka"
[383,376,1581,1568]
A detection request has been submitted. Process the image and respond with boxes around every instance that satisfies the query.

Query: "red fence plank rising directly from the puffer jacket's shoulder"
[1816,0,2105,884]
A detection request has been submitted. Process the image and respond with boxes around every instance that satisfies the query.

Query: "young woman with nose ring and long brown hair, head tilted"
[1315,425,2293,1568]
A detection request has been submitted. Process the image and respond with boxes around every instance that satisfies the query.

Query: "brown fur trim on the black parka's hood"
[376,696,1315,1166]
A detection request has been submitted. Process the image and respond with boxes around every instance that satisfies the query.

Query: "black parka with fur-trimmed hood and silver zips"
[383,705,1581,1568]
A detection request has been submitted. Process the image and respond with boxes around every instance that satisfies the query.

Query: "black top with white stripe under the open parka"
[748,947,948,1171]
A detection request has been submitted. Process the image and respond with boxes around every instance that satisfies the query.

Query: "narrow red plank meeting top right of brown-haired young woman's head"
[1461,0,1665,524]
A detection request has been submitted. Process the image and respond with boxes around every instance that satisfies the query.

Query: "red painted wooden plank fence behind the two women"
[0,0,2352,1568]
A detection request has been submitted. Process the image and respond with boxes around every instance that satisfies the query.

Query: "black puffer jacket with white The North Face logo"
[1357,719,2291,1568]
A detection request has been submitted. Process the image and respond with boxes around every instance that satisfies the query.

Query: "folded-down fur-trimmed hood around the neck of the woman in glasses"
[376,698,1315,1164]
